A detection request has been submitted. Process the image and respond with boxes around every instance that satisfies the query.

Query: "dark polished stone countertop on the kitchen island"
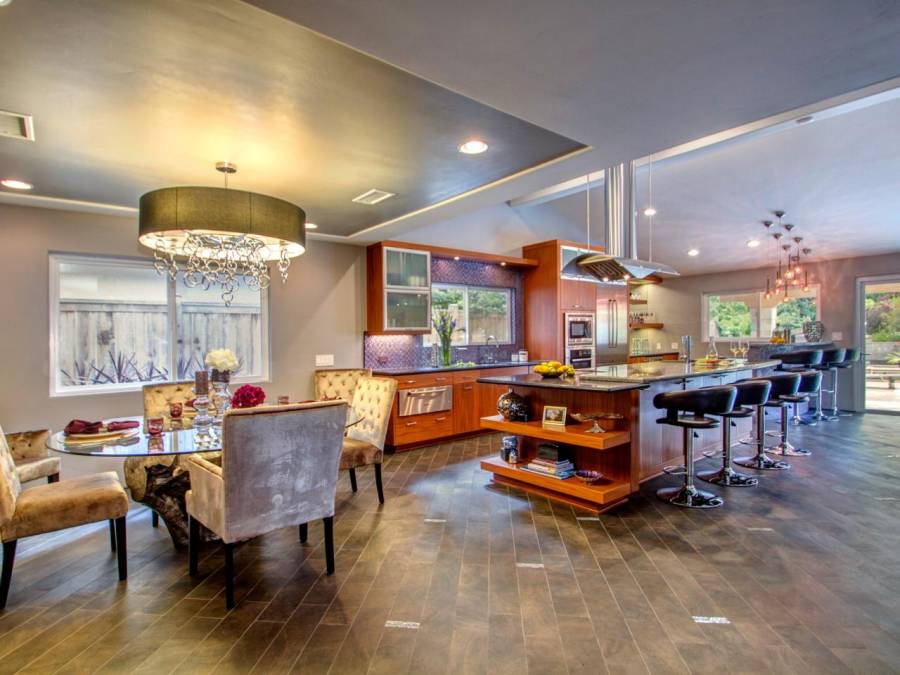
[479,359,781,391]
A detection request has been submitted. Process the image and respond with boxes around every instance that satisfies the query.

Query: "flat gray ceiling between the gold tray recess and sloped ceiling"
[251,0,900,245]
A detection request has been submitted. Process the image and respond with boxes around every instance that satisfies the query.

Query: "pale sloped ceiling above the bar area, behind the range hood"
[517,94,900,274]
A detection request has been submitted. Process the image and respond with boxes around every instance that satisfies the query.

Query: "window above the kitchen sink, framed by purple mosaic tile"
[425,284,513,345]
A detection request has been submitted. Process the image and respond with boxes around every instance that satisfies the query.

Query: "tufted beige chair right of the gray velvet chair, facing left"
[341,377,397,504]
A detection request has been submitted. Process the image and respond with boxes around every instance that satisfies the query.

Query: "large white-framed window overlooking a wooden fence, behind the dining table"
[50,254,269,396]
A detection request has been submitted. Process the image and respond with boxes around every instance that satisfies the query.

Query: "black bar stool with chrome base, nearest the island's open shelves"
[653,387,737,509]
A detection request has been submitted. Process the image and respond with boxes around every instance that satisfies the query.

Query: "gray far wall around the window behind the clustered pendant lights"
[647,253,900,409]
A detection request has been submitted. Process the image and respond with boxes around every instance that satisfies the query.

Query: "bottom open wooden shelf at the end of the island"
[481,457,631,511]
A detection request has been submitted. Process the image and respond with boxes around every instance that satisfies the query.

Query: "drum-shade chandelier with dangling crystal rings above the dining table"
[138,162,306,305]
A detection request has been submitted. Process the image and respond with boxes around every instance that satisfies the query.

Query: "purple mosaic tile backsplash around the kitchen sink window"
[363,256,524,370]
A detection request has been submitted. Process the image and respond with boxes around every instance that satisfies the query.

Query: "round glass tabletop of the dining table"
[47,410,363,457]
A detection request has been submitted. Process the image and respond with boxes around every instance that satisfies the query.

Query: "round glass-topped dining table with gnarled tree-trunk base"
[47,408,364,549]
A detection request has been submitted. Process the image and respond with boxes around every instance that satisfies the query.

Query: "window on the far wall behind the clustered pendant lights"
[703,286,819,341]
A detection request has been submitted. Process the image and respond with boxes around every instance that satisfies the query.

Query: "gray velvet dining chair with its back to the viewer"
[186,401,347,609]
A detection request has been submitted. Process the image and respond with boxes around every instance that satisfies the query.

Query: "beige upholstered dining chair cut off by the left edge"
[0,422,128,609]
